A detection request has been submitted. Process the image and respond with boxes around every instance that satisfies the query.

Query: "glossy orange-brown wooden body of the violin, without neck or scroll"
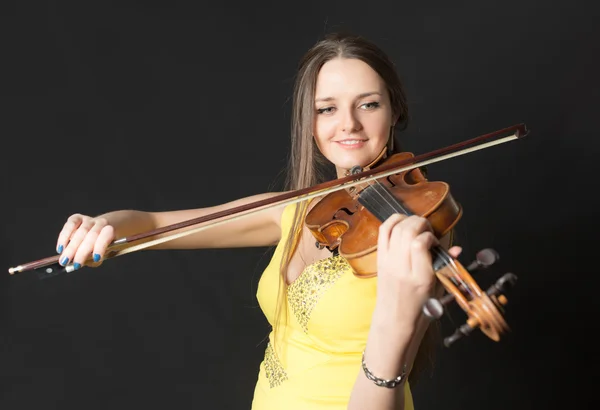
[306,152,462,278]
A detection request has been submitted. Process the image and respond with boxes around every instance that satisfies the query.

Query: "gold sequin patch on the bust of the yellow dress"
[288,255,350,332]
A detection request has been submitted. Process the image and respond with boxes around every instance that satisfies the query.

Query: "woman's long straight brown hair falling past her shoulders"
[275,33,435,383]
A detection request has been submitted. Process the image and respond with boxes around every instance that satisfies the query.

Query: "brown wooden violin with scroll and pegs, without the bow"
[305,152,517,346]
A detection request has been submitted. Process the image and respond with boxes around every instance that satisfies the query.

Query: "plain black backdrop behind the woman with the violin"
[0,0,600,410]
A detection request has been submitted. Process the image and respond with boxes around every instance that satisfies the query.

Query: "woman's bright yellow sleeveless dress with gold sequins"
[252,204,413,410]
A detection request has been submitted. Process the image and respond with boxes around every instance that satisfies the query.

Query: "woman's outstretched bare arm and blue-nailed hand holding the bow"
[57,193,283,270]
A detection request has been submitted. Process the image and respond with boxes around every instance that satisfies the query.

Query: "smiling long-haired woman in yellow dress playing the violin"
[57,35,460,410]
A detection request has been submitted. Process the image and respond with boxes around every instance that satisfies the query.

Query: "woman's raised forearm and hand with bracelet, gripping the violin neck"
[348,219,456,410]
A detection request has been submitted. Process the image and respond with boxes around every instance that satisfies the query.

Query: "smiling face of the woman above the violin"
[313,58,394,177]
